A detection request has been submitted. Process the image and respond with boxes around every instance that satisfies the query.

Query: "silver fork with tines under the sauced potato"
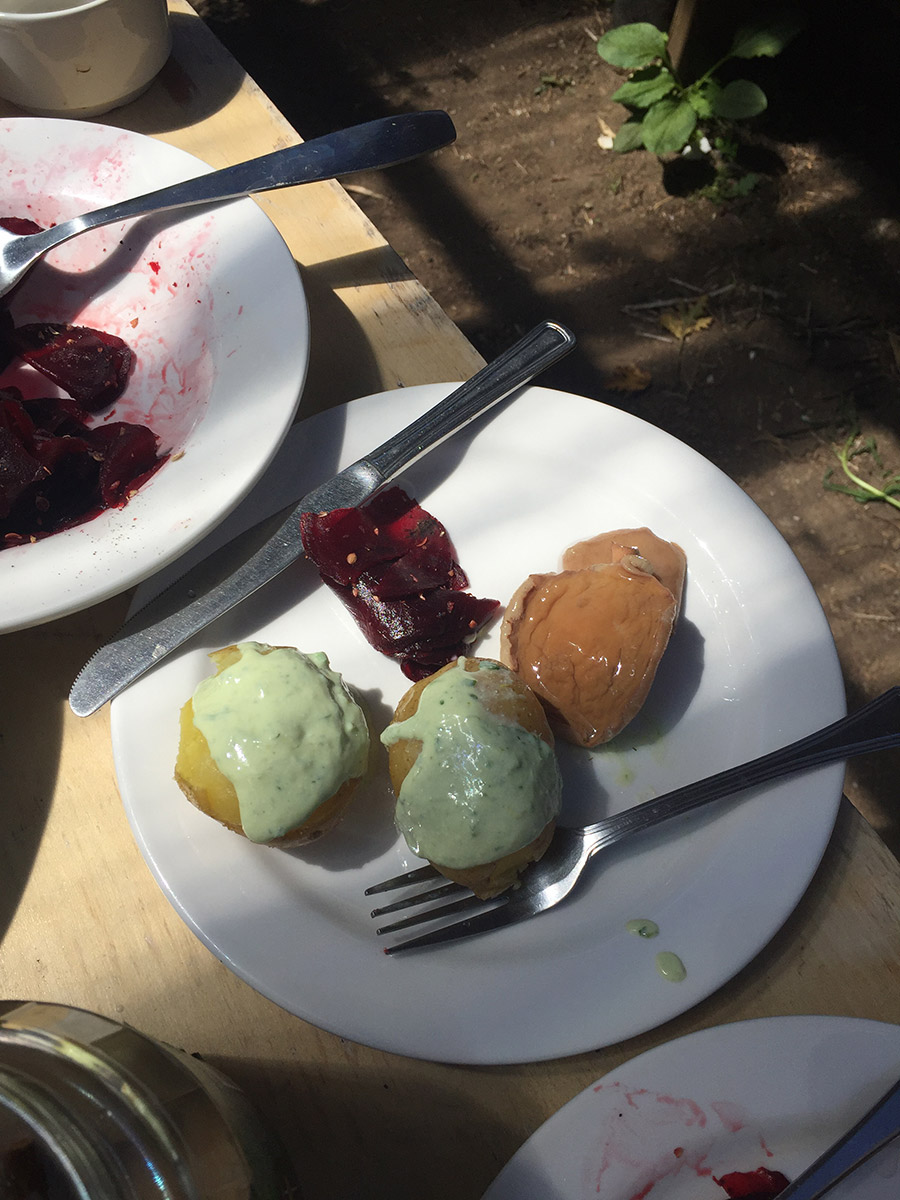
[365,688,900,954]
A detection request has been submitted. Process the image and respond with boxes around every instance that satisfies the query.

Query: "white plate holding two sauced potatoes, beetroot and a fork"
[113,385,844,1063]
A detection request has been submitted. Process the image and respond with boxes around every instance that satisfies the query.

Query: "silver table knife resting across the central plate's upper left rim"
[68,320,575,716]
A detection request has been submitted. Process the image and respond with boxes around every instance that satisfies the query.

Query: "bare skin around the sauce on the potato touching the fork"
[388,658,556,900]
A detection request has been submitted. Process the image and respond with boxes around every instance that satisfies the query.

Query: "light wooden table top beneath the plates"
[0,0,900,1200]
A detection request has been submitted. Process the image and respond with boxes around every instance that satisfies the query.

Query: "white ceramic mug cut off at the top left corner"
[0,0,172,116]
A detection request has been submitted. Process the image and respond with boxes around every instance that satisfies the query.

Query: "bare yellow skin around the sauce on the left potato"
[175,646,360,850]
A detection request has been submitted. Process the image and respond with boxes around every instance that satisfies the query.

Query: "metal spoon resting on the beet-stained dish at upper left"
[0,110,456,296]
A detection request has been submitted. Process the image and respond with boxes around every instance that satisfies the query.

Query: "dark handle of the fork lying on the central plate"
[584,688,900,854]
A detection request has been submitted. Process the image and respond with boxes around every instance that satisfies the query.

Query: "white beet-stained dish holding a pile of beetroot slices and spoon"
[0,116,308,632]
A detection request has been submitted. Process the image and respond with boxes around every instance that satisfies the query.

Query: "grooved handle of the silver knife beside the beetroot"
[365,320,575,482]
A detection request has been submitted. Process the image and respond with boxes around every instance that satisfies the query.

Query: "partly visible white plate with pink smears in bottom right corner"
[484,1016,900,1200]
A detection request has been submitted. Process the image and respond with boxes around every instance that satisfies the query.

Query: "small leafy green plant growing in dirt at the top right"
[596,16,802,161]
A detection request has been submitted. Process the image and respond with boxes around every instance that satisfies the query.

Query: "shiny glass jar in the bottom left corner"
[0,1001,299,1200]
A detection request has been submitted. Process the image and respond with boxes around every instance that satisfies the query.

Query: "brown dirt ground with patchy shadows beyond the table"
[199,0,900,854]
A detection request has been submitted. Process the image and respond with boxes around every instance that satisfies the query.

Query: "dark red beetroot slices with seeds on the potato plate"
[300,487,499,680]
